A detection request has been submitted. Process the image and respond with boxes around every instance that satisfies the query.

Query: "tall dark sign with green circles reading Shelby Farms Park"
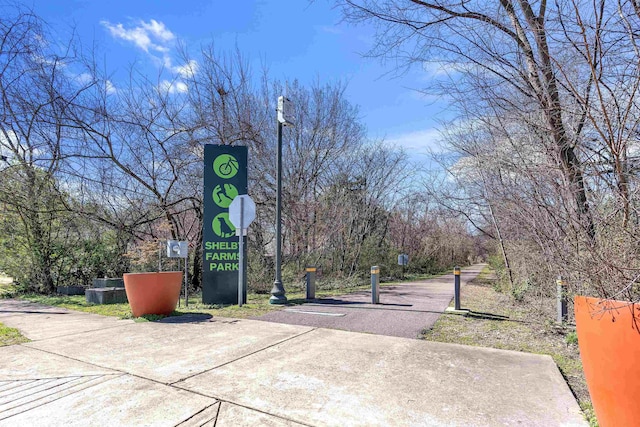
[202,145,247,304]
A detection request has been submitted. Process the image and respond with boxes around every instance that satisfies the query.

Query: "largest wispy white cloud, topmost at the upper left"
[100,19,176,52]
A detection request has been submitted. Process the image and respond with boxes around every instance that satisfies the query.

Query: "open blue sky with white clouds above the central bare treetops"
[31,0,450,154]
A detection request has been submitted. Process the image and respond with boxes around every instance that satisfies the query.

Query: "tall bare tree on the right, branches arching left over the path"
[339,0,595,238]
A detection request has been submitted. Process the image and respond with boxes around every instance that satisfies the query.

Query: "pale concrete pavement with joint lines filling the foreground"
[0,300,587,427]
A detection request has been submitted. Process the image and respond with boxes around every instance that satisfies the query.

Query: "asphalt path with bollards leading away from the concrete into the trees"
[256,264,485,338]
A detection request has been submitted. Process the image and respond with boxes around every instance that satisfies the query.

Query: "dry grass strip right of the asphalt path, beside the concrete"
[421,267,598,427]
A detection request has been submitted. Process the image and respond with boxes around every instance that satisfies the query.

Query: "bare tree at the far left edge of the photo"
[0,5,98,292]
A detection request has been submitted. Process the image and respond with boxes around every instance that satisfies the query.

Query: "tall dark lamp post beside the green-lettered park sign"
[269,96,293,304]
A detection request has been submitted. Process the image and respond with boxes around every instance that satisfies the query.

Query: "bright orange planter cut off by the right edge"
[574,296,640,427]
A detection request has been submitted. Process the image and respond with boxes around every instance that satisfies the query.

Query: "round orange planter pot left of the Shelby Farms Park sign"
[123,271,182,317]
